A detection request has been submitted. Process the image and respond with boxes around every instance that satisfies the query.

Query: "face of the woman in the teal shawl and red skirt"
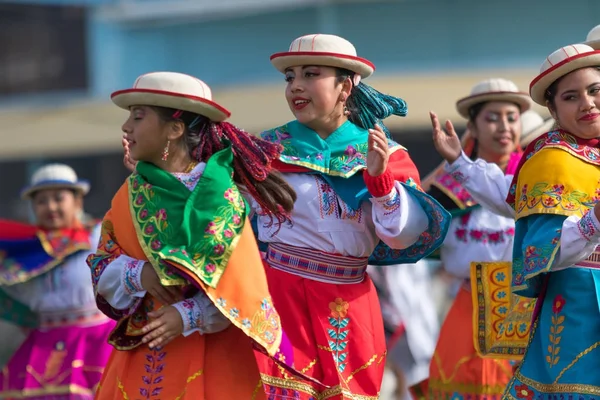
[285,65,351,131]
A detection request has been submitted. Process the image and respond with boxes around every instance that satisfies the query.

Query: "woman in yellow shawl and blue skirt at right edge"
[436,44,600,399]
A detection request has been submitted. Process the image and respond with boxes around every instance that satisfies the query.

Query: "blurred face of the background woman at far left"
[31,189,83,229]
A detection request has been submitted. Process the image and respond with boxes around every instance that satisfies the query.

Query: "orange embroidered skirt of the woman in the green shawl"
[95,296,265,400]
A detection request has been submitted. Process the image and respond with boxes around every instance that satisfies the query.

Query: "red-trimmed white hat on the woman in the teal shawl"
[271,33,375,78]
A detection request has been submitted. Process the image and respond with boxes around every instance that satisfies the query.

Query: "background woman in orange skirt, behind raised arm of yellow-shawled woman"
[415,78,531,399]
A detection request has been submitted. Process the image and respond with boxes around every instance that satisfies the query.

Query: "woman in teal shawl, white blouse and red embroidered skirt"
[248,34,449,399]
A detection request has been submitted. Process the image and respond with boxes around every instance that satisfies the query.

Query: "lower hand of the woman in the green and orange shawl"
[142,306,183,349]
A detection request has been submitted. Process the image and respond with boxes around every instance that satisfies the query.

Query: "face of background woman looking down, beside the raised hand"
[469,101,521,156]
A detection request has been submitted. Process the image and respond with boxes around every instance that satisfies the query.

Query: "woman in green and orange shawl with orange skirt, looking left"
[88,72,295,400]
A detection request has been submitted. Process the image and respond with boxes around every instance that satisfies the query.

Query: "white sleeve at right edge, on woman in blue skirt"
[552,209,600,271]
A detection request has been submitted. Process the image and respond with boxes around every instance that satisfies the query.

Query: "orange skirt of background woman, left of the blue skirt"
[425,287,512,400]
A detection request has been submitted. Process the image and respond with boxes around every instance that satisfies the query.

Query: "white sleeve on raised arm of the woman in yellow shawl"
[445,153,515,218]
